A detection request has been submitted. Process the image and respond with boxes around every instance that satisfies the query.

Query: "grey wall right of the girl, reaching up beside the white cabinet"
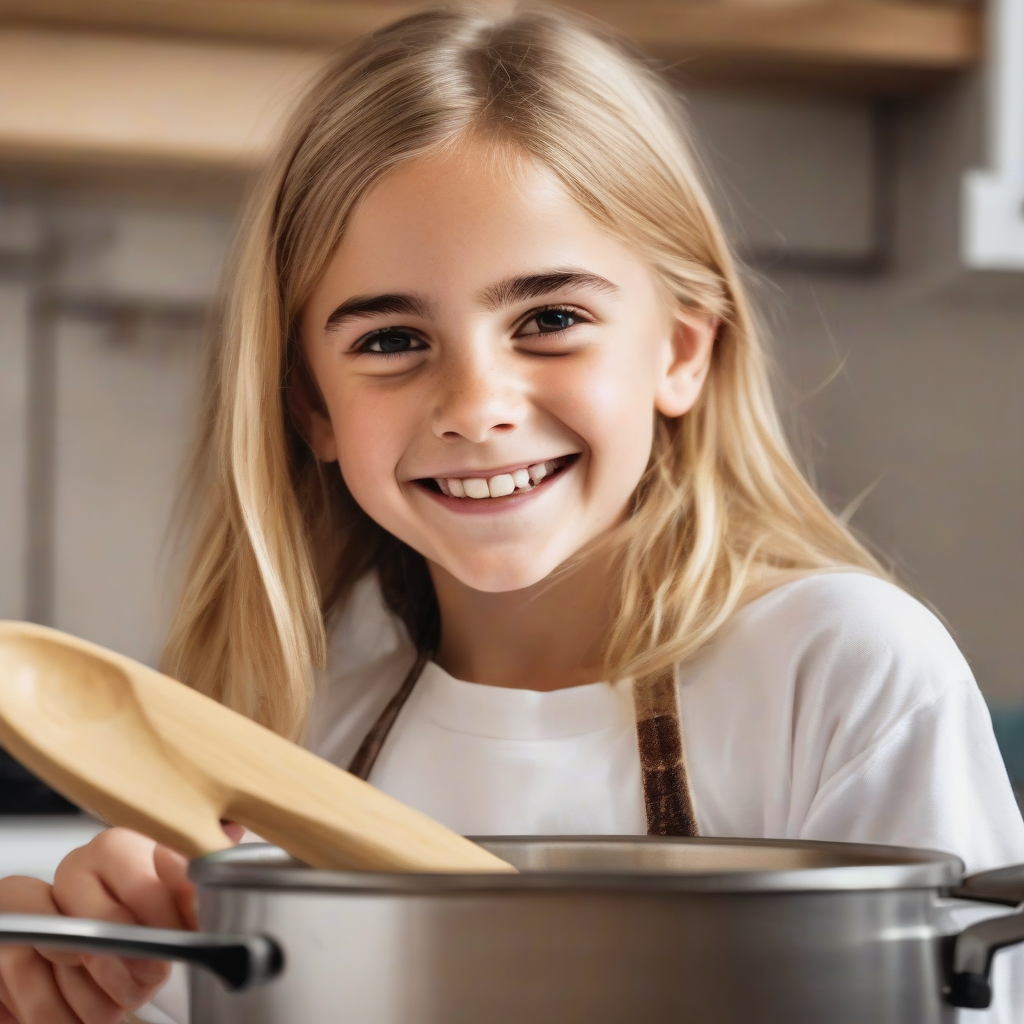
[745,80,1024,705]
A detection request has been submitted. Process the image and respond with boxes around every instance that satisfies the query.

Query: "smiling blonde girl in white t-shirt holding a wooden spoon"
[0,4,1024,1024]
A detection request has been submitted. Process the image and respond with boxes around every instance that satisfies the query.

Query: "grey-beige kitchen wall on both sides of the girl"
[0,75,1024,702]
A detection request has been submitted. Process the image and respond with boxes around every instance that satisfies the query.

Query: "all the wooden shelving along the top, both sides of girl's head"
[0,0,981,180]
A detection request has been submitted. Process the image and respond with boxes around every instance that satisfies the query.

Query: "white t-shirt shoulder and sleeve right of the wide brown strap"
[680,572,1024,870]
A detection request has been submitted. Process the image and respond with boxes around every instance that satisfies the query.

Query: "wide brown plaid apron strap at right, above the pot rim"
[633,669,700,836]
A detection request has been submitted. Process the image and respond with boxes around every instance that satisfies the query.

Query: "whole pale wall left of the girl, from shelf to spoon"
[0,196,222,664]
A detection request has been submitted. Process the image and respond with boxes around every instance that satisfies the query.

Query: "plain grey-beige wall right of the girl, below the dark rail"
[763,273,1024,703]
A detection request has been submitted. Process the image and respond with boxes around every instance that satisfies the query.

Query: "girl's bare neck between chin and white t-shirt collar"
[430,557,614,690]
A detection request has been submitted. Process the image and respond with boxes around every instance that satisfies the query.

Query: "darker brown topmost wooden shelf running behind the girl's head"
[0,0,981,94]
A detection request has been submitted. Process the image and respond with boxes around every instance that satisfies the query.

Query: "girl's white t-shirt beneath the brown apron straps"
[146,572,1024,1021]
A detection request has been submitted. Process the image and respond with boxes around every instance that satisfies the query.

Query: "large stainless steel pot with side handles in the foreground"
[0,837,1024,1024]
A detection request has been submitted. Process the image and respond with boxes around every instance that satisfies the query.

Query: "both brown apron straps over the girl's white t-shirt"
[348,650,699,836]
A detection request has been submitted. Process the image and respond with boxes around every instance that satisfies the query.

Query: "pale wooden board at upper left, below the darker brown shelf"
[0,28,325,171]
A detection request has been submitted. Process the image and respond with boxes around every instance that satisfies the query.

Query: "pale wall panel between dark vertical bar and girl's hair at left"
[52,317,200,664]
